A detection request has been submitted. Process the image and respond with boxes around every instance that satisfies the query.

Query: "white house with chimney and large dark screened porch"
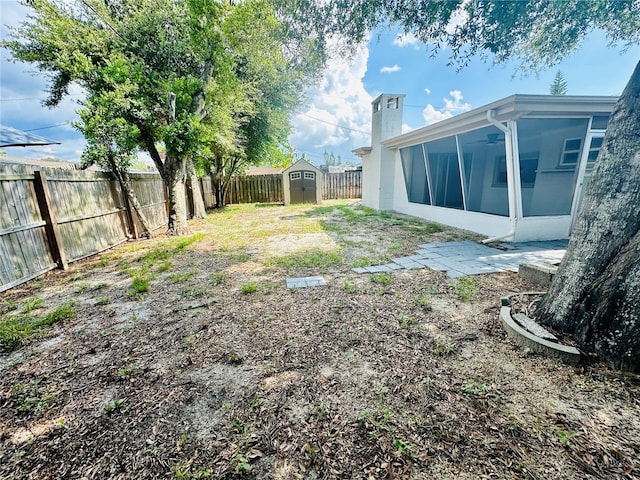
[354,94,617,242]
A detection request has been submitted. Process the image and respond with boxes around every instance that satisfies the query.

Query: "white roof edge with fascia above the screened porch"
[382,94,618,148]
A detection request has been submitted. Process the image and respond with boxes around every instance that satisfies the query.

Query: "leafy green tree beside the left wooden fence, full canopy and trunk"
[2,0,324,228]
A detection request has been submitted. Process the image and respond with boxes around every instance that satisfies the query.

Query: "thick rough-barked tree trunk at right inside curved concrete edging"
[538,60,640,373]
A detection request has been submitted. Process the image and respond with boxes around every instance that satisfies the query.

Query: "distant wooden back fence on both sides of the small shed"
[226,170,362,203]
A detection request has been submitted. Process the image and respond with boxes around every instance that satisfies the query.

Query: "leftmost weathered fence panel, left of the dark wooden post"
[0,165,56,291]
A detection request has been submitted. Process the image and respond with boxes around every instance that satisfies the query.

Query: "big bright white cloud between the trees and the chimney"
[289,42,372,160]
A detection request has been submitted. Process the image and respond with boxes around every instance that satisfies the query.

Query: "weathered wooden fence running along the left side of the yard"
[0,165,167,291]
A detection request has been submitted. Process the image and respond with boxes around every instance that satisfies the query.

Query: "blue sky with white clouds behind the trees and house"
[0,0,640,165]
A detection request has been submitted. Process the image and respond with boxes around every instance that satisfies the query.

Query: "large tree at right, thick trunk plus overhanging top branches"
[331,0,640,372]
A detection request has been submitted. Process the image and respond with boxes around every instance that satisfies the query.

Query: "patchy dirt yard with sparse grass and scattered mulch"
[0,201,640,480]
